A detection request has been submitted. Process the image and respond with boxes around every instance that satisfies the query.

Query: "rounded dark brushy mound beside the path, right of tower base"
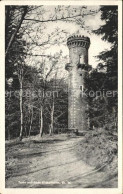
[77,128,118,167]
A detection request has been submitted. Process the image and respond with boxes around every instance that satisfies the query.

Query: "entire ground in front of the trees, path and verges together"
[6,134,117,188]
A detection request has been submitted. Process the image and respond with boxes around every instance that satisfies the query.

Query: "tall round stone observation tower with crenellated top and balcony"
[65,36,91,131]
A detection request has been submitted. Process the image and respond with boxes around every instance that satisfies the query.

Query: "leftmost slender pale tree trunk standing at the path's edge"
[19,80,23,141]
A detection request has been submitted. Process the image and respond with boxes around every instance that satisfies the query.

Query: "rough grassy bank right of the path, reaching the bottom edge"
[76,128,118,188]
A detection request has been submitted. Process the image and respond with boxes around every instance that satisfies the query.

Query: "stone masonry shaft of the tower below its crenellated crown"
[68,35,88,131]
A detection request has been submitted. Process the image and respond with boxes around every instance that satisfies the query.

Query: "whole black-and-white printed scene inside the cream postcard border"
[0,1,122,193]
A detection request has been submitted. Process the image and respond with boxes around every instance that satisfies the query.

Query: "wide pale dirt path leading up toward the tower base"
[6,137,117,188]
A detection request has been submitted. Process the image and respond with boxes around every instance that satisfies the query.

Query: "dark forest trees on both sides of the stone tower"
[5,6,117,139]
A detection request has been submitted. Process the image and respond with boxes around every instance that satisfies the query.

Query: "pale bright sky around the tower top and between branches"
[23,6,111,78]
